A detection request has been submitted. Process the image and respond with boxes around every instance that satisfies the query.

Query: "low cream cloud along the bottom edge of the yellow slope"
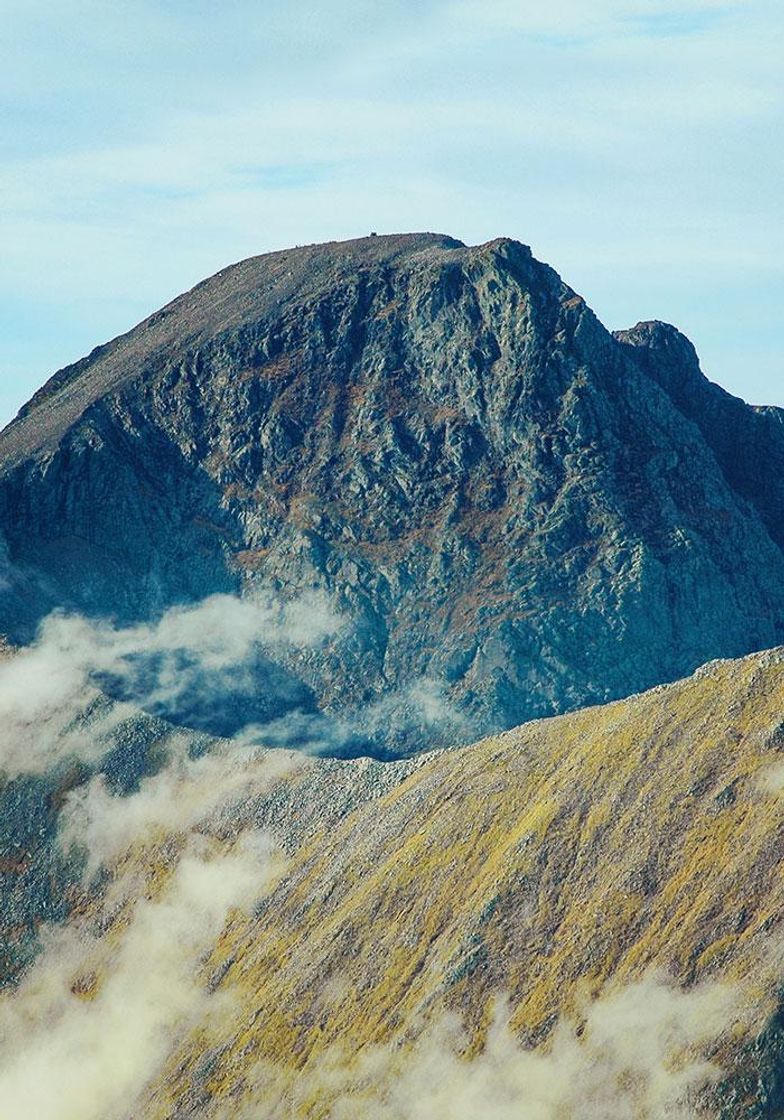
[215,973,754,1120]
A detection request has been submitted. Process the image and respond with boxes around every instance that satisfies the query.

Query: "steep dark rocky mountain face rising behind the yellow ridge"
[0,234,784,734]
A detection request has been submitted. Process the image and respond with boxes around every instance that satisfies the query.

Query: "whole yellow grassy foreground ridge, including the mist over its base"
[7,650,784,1120]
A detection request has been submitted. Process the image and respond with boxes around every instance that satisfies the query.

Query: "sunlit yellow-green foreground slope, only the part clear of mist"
[131,651,784,1117]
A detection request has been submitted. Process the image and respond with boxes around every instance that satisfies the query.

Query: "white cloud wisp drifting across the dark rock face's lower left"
[0,592,343,776]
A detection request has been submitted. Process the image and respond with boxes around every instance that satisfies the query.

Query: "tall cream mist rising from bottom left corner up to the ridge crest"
[0,734,292,1120]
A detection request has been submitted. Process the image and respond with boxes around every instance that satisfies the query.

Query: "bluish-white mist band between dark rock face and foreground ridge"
[0,591,469,776]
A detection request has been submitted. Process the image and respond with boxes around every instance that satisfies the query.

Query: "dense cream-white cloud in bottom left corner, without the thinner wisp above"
[0,833,281,1120]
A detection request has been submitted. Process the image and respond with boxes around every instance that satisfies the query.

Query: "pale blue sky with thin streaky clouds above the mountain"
[0,0,784,421]
